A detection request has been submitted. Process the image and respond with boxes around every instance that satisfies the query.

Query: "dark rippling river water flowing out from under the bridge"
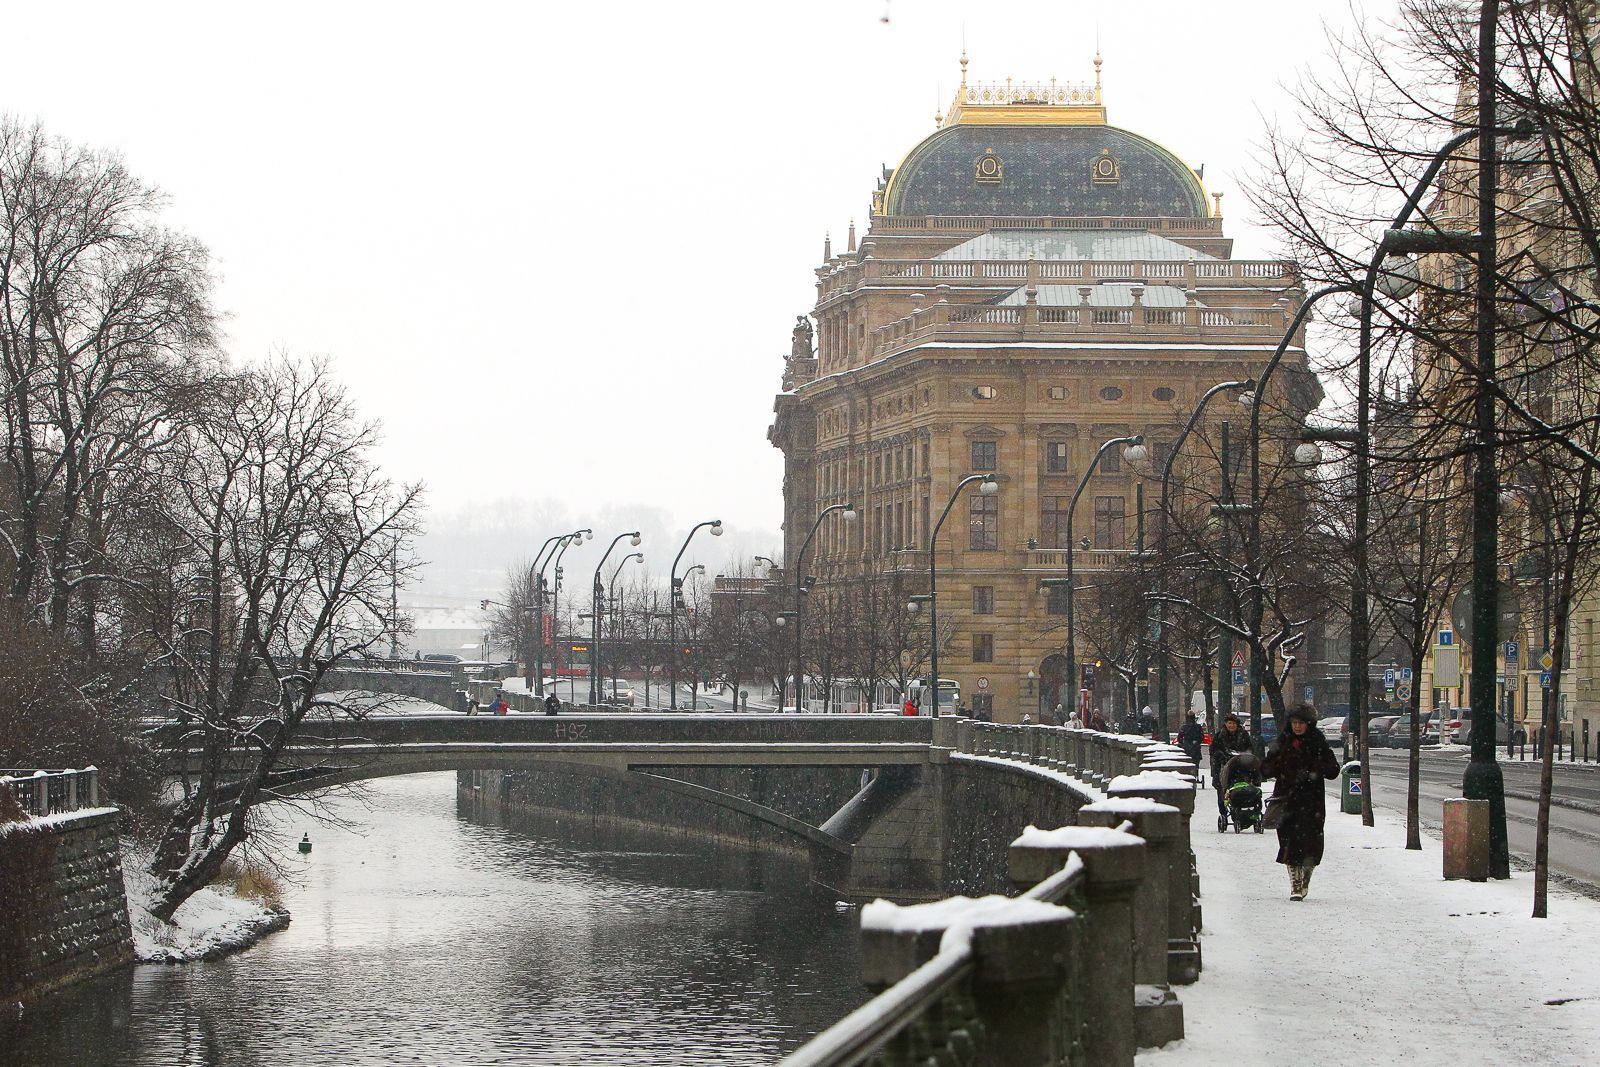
[0,774,864,1067]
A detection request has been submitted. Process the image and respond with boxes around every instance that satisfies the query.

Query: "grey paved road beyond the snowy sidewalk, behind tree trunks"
[1363,750,1600,894]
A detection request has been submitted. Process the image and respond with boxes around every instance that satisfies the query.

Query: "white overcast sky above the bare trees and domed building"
[0,0,1392,588]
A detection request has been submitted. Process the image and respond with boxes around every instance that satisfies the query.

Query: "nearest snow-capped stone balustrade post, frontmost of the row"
[861,896,1075,1064]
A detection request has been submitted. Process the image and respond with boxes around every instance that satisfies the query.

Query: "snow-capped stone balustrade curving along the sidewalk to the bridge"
[782,720,1198,1067]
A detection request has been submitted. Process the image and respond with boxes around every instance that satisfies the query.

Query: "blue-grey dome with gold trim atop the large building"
[874,54,1211,219]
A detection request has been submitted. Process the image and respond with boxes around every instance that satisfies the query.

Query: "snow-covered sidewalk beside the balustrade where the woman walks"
[1138,790,1600,1067]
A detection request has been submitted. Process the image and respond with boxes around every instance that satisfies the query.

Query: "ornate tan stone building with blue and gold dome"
[770,54,1320,721]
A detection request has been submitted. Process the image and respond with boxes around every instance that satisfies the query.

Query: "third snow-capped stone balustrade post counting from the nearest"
[1078,797,1184,1048]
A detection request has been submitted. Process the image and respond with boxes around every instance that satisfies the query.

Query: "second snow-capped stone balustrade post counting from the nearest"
[1010,827,1146,1067]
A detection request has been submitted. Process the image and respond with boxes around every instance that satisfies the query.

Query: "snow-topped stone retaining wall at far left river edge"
[0,808,133,1003]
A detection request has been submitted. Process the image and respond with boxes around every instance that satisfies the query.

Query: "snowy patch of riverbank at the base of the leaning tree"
[122,849,290,963]
